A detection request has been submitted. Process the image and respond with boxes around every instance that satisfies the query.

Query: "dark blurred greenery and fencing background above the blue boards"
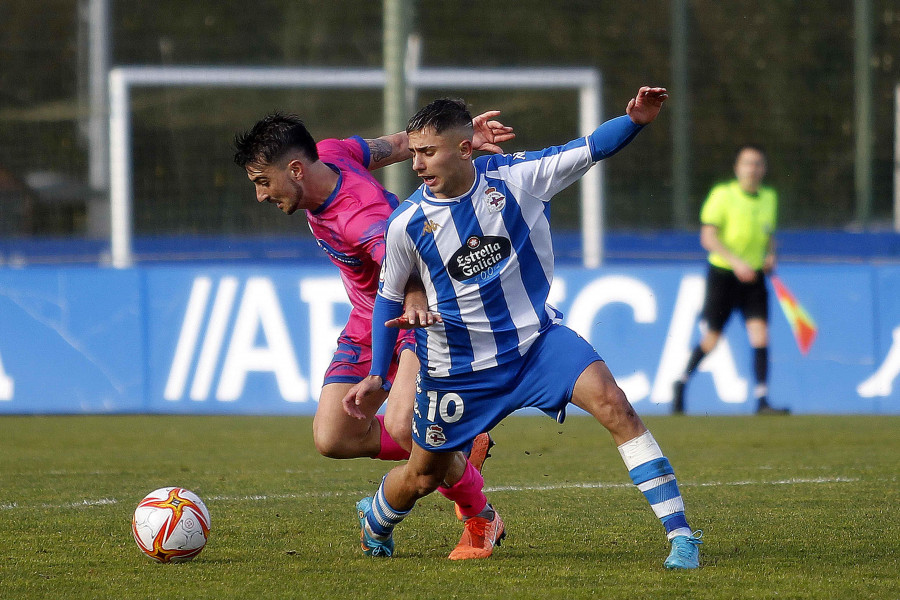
[0,0,900,236]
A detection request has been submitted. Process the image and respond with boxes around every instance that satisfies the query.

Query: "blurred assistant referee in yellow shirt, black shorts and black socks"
[673,145,788,414]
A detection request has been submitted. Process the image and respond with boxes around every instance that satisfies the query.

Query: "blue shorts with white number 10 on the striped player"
[413,325,603,452]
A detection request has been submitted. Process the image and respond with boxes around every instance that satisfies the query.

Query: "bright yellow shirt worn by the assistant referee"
[700,180,778,270]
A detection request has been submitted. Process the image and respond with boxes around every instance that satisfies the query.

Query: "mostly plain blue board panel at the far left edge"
[0,268,145,413]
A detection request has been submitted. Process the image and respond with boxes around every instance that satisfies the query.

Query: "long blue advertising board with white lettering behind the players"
[0,263,900,415]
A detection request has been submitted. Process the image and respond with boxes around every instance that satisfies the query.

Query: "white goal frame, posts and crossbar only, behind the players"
[109,66,605,268]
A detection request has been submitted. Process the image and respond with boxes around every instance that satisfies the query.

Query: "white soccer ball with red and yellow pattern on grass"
[131,487,209,562]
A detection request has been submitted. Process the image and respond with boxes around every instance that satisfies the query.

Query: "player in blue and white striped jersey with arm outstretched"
[344,87,701,568]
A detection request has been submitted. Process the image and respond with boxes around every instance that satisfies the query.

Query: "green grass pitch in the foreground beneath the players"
[0,416,900,600]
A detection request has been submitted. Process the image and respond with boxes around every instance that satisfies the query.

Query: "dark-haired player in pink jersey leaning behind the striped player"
[234,111,515,540]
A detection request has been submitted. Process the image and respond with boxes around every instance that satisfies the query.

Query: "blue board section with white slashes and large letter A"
[147,267,342,414]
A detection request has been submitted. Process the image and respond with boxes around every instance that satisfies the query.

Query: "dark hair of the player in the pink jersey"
[234,112,319,168]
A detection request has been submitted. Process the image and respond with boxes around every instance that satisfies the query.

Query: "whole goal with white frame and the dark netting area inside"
[108,67,603,267]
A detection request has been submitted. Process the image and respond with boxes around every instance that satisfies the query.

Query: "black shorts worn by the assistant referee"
[702,265,769,332]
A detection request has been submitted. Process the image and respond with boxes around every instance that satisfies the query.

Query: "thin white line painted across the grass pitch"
[0,477,859,511]
